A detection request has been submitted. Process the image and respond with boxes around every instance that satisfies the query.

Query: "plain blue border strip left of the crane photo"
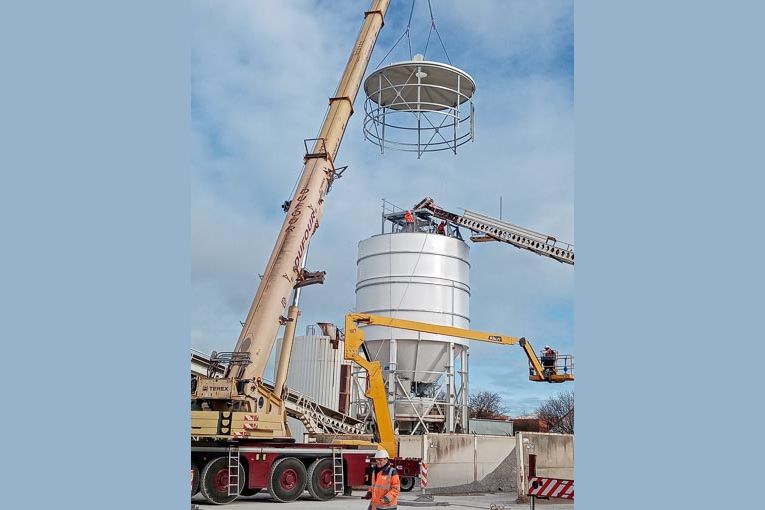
[0,1,190,510]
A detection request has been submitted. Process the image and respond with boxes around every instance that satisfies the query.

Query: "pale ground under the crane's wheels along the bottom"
[191,491,574,510]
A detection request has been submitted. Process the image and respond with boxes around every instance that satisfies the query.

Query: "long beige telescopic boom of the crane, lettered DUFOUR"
[226,0,390,379]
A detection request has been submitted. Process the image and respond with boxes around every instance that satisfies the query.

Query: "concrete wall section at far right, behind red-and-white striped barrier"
[515,432,574,496]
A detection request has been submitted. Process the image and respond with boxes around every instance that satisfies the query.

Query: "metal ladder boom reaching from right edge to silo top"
[412,197,574,266]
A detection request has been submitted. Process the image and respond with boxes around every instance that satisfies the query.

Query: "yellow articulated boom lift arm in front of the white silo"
[344,313,574,457]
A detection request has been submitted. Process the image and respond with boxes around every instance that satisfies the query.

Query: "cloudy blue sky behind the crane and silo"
[191,0,575,415]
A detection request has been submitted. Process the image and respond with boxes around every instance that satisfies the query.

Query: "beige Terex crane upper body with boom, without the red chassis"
[192,0,390,438]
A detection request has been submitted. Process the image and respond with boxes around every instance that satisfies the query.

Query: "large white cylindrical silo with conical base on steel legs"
[356,232,470,433]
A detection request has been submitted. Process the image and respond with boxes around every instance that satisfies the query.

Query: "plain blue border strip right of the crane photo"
[575,0,765,509]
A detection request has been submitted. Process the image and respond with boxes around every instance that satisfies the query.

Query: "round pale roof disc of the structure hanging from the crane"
[364,60,475,111]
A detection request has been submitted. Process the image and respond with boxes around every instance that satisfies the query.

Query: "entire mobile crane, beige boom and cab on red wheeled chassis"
[191,0,419,504]
